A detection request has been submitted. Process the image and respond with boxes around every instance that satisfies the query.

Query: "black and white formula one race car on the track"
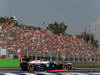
[21,57,72,72]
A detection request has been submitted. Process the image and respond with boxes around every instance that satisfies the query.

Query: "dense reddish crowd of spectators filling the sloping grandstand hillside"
[0,16,96,59]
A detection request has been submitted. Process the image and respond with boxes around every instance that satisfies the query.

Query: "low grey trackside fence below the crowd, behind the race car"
[26,55,100,63]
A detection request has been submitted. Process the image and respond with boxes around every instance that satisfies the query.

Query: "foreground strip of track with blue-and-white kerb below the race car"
[0,69,100,75]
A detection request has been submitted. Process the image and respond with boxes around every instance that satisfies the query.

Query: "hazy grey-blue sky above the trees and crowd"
[0,0,100,40]
